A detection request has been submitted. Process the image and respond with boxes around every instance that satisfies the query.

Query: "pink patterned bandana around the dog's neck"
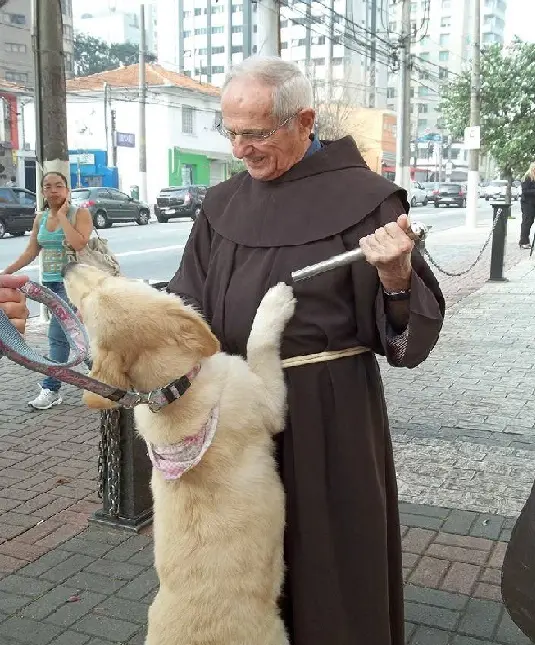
[147,405,219,479]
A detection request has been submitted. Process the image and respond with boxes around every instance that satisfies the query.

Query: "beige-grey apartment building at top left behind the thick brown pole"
[0,0,74,88]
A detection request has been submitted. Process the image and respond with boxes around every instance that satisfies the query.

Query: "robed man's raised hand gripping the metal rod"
[359,215,414,291]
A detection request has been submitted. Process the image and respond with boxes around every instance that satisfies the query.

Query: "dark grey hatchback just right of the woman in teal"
[71,187,150,228]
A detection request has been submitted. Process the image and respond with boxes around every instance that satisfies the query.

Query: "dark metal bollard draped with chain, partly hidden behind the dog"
[90,280,168,532]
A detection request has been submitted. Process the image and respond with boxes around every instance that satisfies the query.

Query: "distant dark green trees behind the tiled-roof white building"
[74,33,156,76]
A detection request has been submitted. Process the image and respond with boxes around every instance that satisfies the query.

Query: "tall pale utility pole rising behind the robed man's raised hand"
[396,0,412,191]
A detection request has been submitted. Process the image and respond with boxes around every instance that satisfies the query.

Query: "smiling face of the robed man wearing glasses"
[221,79,314,181]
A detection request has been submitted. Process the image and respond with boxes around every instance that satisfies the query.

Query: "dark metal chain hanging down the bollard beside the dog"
[98,410,121,517]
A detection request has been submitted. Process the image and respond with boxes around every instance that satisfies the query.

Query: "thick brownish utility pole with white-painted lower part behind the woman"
[32,0,71,321]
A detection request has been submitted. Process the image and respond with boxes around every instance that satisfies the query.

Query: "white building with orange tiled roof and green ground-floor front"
[24,65,232,204]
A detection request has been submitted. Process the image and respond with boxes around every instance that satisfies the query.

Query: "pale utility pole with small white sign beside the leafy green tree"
[466,0,481,228]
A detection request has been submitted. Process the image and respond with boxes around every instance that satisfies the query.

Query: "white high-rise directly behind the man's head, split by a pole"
[158,0,390,108]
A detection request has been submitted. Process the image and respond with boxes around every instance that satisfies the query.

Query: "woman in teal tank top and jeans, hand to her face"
[2,172,93,410]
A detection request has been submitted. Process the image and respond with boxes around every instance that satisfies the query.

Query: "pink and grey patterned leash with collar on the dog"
[0,282,200,412]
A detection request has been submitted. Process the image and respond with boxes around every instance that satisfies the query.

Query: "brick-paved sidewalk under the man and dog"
[0,214,535,645]
